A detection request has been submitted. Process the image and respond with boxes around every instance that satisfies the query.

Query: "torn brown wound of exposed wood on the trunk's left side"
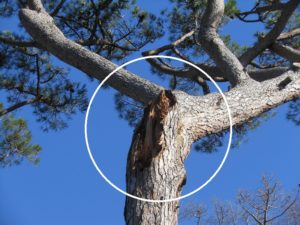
[128,90,176,175]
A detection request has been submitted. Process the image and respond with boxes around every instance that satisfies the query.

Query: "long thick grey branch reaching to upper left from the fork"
[19,9,162,104]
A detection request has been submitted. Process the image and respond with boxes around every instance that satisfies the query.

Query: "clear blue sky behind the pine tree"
[0,0,300,225]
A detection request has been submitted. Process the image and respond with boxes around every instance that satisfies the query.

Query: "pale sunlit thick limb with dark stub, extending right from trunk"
[176,70,300,140]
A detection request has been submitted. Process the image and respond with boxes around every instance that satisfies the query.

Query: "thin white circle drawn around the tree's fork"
[84,55,233,203]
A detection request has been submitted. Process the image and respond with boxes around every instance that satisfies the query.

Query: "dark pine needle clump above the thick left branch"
[45,0,163,60]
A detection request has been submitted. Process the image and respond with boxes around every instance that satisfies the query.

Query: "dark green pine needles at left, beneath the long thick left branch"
[0,41,87,131]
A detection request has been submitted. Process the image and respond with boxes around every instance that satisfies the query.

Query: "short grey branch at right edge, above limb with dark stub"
[270,42,300,62]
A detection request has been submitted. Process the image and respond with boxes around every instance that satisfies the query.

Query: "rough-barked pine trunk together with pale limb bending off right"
[124,67,300,225]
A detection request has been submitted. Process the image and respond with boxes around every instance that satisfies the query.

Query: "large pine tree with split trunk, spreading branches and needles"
[0,0,300,224]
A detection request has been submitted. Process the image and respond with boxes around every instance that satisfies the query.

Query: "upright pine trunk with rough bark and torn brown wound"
[124,91,191,225]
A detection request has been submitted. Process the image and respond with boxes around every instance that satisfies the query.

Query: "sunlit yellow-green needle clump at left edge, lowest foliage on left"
[0,104,41,167]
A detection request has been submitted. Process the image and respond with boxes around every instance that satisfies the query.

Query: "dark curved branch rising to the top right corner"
[240,0,300,66]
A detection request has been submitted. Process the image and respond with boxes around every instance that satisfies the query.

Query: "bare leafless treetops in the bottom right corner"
[180,176,300,225]
